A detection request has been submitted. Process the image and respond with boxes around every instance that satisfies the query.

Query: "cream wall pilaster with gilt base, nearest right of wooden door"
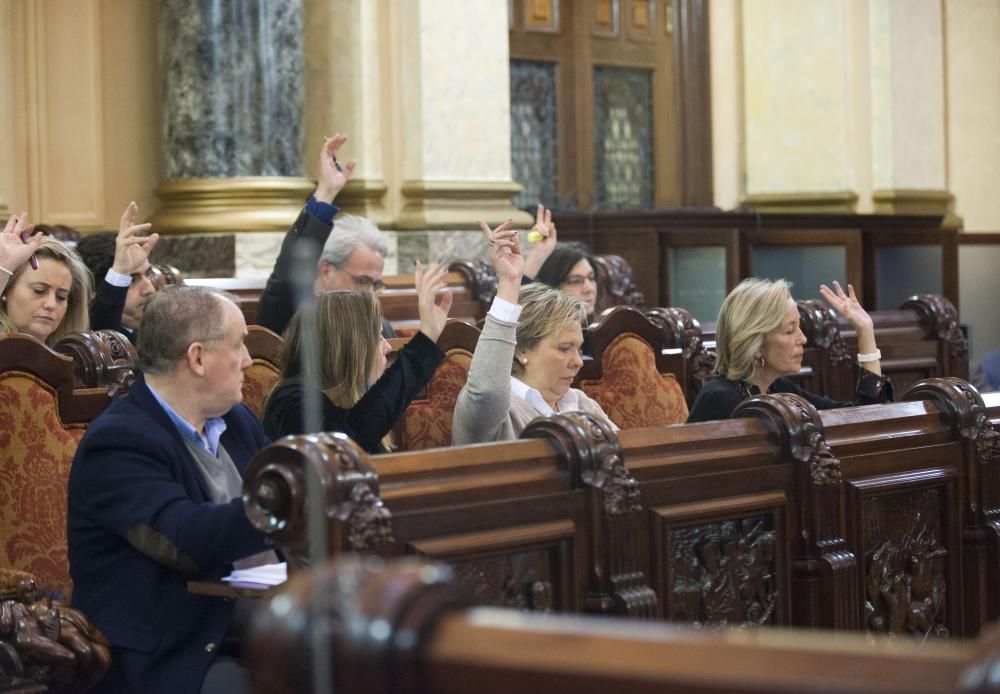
[744,0,858,212]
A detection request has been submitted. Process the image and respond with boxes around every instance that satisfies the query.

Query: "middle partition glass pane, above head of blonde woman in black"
[752,246,847,299]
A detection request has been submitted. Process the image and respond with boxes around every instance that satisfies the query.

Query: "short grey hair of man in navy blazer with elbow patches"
[136,285,236,376]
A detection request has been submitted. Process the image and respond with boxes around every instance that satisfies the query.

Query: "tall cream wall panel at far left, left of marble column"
[25,0,105,229]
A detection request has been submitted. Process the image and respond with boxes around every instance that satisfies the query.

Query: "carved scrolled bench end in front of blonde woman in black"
[734,393,861,629]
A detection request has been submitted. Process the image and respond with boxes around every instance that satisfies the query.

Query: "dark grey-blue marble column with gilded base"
[152,0,313,245]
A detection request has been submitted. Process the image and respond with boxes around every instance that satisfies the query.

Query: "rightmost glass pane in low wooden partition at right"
[875,246,942,310]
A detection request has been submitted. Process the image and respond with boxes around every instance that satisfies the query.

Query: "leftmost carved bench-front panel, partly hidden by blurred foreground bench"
[407,521,580,611]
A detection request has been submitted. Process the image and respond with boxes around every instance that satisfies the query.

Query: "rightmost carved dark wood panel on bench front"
[846,470,962,638]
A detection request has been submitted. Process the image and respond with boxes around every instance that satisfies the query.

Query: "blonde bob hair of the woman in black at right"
[715,277,792,381]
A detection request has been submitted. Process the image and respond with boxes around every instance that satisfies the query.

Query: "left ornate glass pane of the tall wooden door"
[510,60,558,207]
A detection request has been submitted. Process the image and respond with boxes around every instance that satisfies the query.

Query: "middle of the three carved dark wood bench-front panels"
[653,494,788,628]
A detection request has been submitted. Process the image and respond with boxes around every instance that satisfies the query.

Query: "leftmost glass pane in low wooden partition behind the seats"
[669,246,726,322]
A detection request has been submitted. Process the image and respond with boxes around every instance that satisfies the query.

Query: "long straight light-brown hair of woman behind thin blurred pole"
[281,291,382,409]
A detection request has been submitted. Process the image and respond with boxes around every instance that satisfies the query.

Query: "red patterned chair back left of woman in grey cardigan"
[397,349,472,451]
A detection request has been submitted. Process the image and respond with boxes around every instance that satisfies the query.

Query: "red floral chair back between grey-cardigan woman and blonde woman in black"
[580,333,688,429]
